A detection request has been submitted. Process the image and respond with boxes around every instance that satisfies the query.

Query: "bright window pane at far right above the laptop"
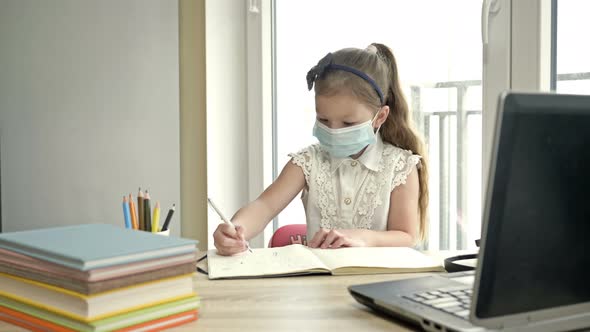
[554,0,590,94]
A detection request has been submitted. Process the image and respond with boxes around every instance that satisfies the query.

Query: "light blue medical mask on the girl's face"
[313,112,379,158]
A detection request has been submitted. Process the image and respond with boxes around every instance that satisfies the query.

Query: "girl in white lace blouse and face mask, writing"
[213,43,428,255]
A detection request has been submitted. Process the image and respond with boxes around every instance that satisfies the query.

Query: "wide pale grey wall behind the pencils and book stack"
[0,0,180,234]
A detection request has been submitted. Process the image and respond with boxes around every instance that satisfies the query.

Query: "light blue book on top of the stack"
[0,224,197,271]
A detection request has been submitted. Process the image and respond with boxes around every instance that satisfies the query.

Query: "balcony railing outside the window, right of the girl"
[410,72,590,250]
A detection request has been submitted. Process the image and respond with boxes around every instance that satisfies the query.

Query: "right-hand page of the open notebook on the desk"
[308,247,442,272]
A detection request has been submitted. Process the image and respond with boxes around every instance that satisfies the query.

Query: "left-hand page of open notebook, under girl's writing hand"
[207,245,328,279]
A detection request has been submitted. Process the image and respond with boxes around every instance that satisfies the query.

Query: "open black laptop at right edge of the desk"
[348,92,590,332]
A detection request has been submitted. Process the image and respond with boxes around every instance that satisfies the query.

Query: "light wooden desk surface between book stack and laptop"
[0,250,472,332]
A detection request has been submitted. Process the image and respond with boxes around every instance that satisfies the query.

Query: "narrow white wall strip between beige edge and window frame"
[205,0,248,248]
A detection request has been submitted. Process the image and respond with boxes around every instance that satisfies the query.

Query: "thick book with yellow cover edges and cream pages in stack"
[0,273,194,322]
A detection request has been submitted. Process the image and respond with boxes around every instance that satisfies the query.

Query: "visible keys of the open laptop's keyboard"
[403,287,471,320]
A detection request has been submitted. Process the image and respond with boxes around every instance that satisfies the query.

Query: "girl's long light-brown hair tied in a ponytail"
[308,43,428,241]
